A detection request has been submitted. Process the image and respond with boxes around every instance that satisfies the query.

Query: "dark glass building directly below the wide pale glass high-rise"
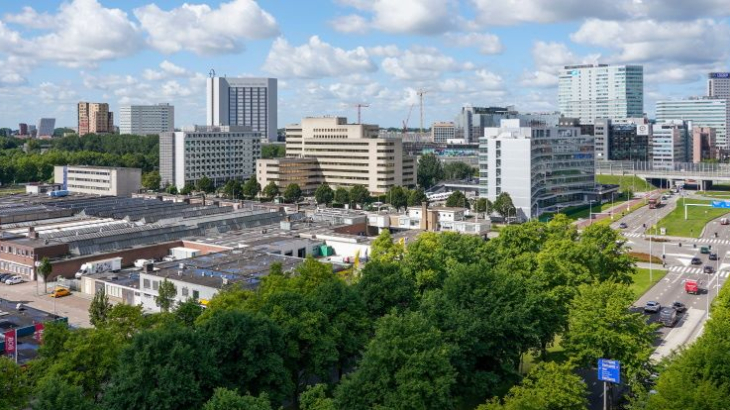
[593,118,651,161]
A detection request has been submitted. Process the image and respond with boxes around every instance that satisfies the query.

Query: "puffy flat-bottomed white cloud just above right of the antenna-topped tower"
[263,36,377,78]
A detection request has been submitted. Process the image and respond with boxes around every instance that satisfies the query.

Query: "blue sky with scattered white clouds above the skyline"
[0,0,730,129]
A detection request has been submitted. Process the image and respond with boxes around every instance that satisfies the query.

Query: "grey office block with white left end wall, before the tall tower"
[160,125,261,189]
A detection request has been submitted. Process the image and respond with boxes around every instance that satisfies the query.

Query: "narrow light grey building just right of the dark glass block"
[651,120,691,170]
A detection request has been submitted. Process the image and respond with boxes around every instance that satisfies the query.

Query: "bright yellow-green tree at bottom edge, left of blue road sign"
[477,362,588,410]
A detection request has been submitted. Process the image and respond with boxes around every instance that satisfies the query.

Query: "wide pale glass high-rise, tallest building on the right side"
[558,64,644,124]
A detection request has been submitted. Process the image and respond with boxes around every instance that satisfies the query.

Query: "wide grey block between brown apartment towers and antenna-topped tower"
[119,104,175,135]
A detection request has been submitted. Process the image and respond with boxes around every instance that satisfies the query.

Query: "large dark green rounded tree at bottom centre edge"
[335,312,456,410]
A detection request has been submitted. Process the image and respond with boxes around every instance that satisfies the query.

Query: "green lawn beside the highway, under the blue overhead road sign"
[657,198,728,238]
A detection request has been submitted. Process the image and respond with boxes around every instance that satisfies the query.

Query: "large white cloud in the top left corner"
[0,0,141,67]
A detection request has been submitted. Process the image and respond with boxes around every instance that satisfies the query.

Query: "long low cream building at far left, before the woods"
[53,165,142,196]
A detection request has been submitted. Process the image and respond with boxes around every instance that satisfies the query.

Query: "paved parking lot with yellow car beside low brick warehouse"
[0,282,91,327]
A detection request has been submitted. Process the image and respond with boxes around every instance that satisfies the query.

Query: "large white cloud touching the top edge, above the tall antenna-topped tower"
[134,0,279,55]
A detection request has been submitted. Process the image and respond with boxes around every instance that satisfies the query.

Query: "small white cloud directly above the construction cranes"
[382,47,474,80]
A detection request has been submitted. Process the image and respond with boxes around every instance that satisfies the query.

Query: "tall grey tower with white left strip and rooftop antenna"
[206,77,278,142]
